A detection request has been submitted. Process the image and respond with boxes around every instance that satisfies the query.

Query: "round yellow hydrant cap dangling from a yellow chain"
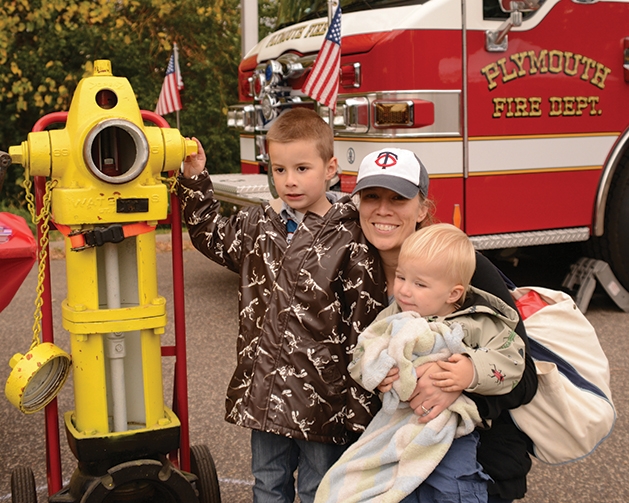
[4,342,71,414]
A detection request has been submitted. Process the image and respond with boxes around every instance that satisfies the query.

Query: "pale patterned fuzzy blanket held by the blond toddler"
[315,312,480,503]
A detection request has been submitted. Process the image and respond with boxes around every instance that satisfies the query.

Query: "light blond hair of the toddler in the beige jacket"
[398,224,476,291]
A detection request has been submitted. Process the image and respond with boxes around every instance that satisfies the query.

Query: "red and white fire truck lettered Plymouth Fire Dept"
[228,0,629,289]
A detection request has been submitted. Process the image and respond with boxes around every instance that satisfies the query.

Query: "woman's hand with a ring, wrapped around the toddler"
[408,362,461,423]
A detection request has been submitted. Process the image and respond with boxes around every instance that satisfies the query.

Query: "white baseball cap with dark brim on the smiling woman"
[352,148,428,199]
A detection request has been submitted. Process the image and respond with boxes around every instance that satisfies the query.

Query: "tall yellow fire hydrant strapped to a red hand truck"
[9,60,196,501]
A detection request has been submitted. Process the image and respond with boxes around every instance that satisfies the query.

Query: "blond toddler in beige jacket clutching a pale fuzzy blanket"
[316,224,524,503]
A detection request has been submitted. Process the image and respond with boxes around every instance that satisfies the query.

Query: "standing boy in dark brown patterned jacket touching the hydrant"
[174,109,386,503]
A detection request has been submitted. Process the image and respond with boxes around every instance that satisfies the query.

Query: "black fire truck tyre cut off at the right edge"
[592,153,629,290]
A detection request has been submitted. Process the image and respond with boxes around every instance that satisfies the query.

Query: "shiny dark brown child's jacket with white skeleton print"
[179,172,387,444]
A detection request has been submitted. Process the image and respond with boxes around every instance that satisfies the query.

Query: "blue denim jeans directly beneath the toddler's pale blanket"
[402,432,489,503]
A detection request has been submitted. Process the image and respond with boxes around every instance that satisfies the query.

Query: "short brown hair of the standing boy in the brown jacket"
[266,108,334,162]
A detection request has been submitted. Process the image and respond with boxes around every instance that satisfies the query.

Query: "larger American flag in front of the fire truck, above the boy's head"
[302,2,341,111]
